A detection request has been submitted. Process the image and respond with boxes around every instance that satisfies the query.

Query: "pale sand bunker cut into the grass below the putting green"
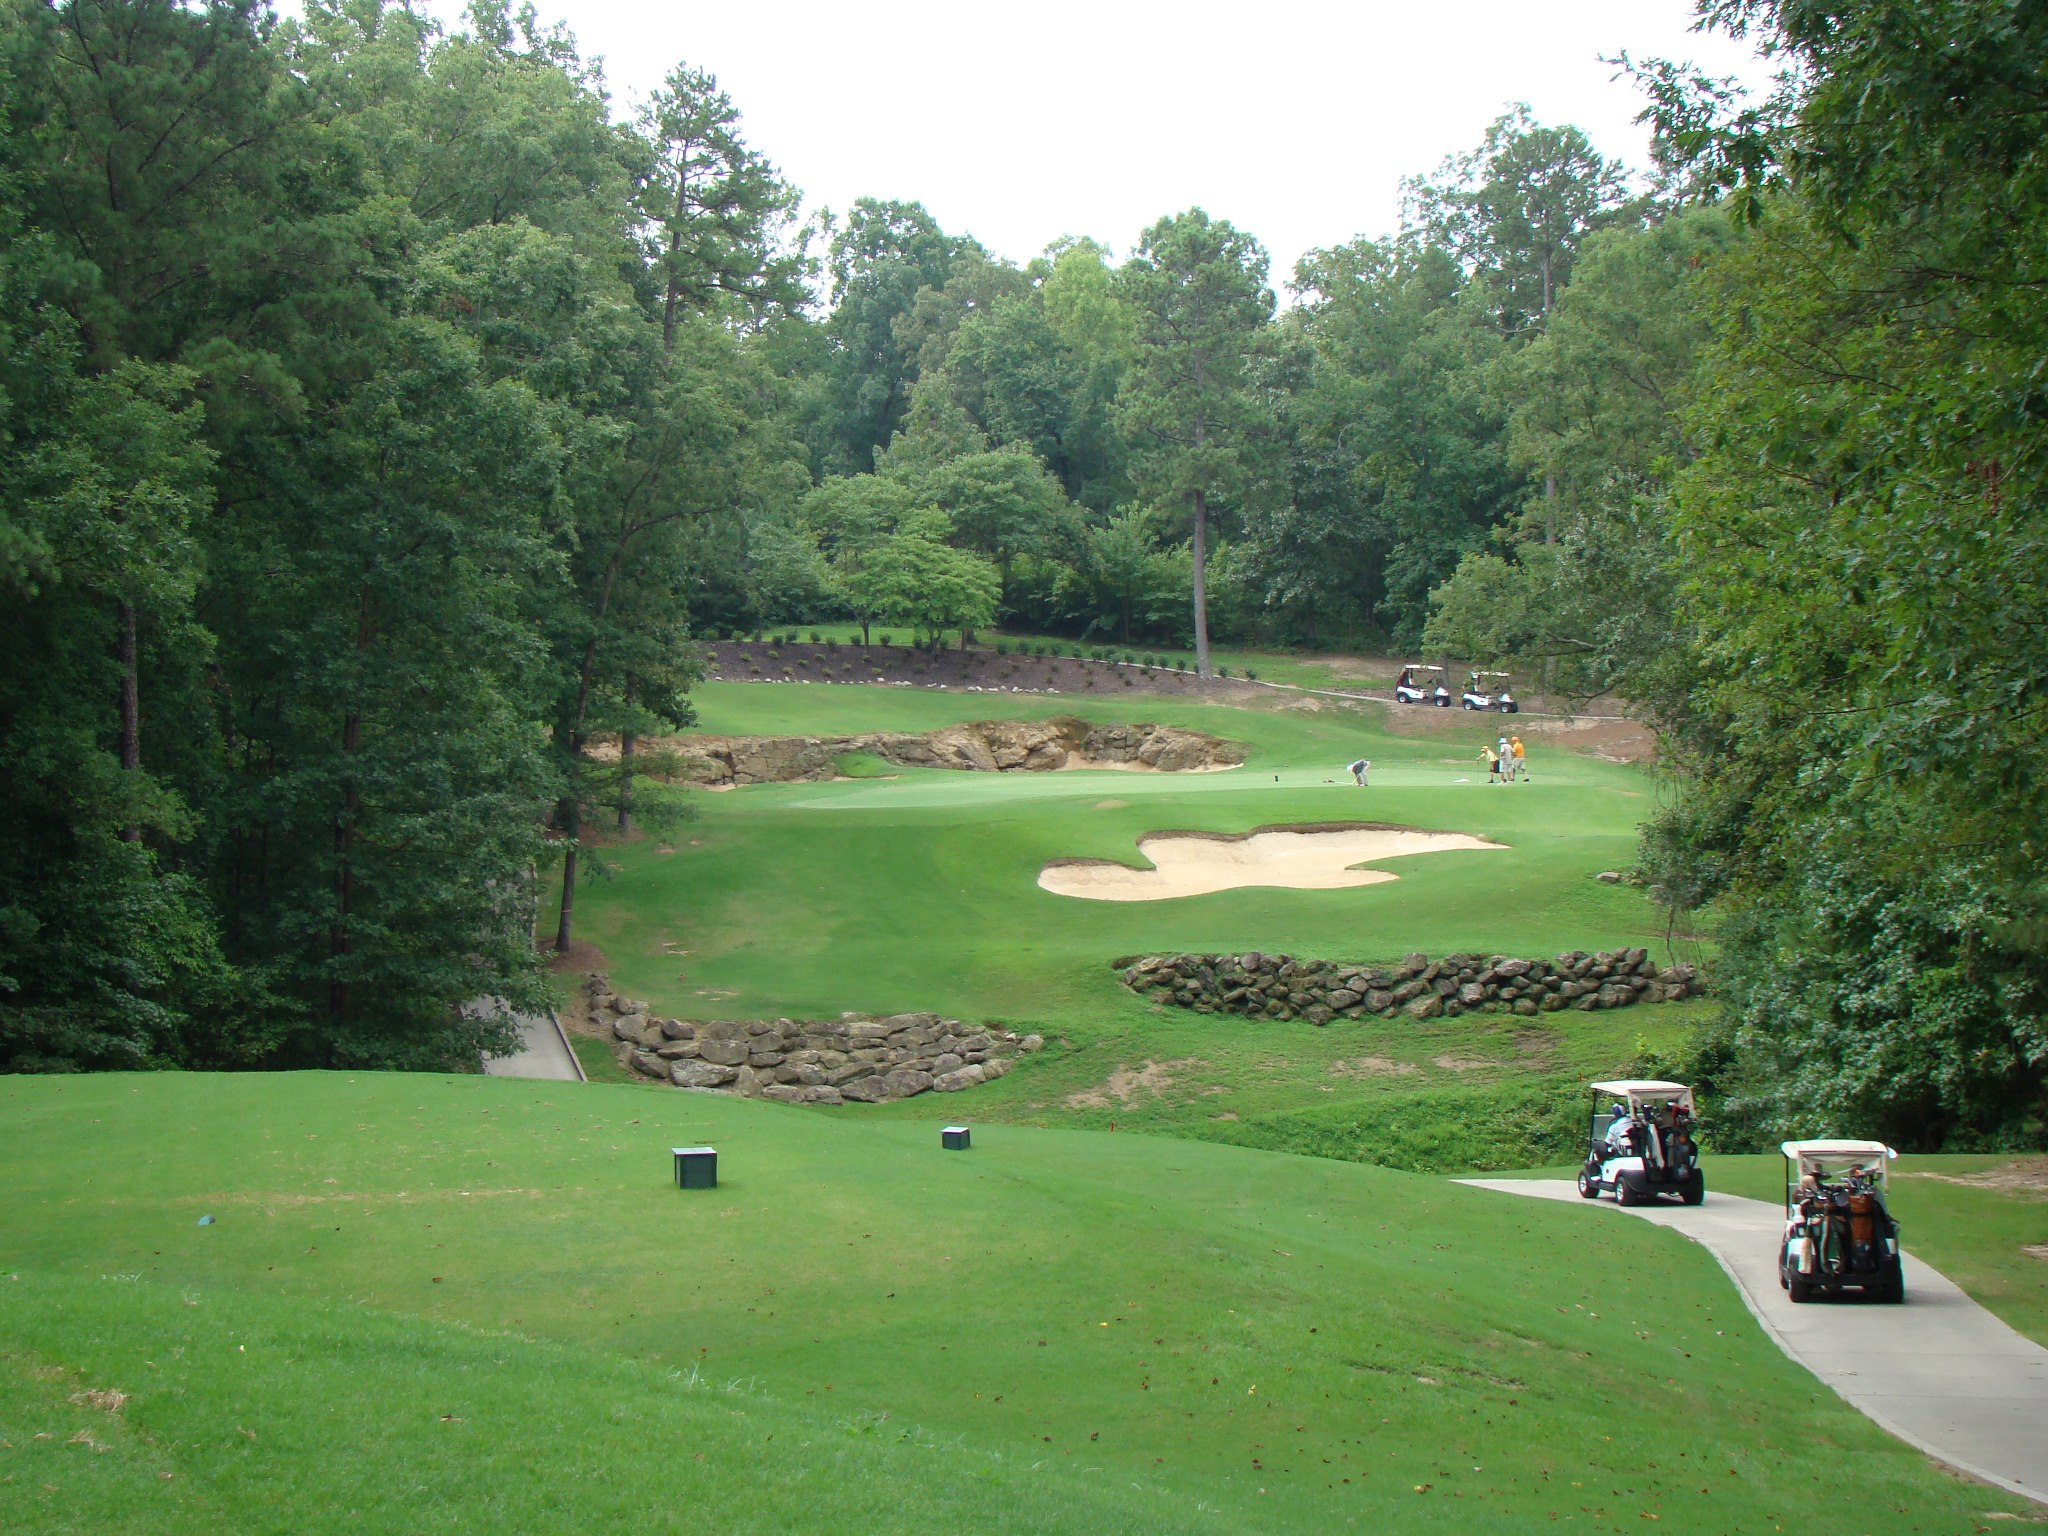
[1038,823,1503,901]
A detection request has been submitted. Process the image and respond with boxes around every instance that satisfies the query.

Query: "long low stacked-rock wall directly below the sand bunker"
[1120,948,1700,1024]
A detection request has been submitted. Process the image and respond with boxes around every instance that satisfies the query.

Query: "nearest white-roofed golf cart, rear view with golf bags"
[1778,1141,1907,1300]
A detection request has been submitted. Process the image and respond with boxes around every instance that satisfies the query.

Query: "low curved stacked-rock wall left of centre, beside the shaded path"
[588,975,1044,1104]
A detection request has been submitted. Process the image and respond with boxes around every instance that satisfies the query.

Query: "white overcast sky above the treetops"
[407,0,1765,283]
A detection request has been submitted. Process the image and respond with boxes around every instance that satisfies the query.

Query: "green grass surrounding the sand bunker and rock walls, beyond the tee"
[563,684,1702,1171]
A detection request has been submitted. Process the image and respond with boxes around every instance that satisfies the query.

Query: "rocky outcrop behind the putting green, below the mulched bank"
[600,715,1245,786]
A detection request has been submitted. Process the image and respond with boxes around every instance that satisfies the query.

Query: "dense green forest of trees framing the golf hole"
[0,0,2048,1145]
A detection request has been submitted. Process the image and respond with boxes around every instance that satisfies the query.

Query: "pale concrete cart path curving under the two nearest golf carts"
[1460,1180,2048,1503]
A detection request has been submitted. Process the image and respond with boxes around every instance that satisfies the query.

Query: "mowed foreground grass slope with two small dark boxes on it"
[0,1075,2015,1532]
